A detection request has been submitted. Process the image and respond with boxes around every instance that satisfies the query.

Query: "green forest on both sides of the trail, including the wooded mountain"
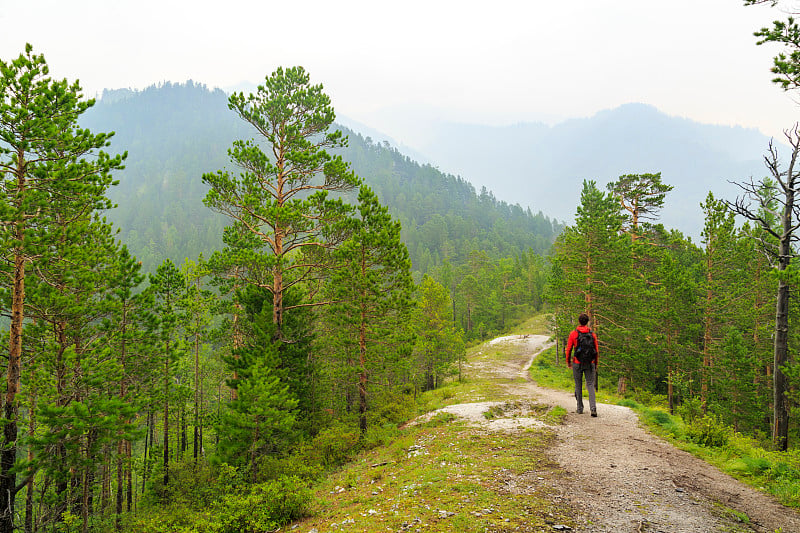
[0,6,800,533]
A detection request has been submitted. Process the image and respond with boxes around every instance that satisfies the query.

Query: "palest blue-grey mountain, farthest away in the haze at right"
[372,104,780,238]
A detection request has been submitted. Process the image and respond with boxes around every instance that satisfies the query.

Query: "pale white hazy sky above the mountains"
[0,0,800,141]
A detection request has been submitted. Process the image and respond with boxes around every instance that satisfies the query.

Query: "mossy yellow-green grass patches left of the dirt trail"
[294,319,574,532]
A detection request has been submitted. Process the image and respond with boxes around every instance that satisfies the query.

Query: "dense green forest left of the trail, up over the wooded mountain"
[0,47,560,532]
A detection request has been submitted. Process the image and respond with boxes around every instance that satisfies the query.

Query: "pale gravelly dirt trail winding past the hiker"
[460,335,800,533]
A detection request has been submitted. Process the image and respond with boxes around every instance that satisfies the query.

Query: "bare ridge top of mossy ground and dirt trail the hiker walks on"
[292,322,800,533]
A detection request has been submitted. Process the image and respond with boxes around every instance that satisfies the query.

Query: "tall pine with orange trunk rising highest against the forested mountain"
[203,67,359,338]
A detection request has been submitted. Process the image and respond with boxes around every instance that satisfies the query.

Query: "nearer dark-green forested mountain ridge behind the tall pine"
[81,81,560,272]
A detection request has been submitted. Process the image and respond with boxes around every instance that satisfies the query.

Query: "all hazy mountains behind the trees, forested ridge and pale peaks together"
[82,82,788,272]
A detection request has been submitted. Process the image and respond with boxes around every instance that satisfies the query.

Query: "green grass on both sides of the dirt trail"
[294,317,800,532]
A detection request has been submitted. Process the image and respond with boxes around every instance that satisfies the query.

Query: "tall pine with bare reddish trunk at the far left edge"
[0,45,123,533]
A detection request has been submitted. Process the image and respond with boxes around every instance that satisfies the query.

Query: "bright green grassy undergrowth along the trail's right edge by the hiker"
[531,348,800,508]
